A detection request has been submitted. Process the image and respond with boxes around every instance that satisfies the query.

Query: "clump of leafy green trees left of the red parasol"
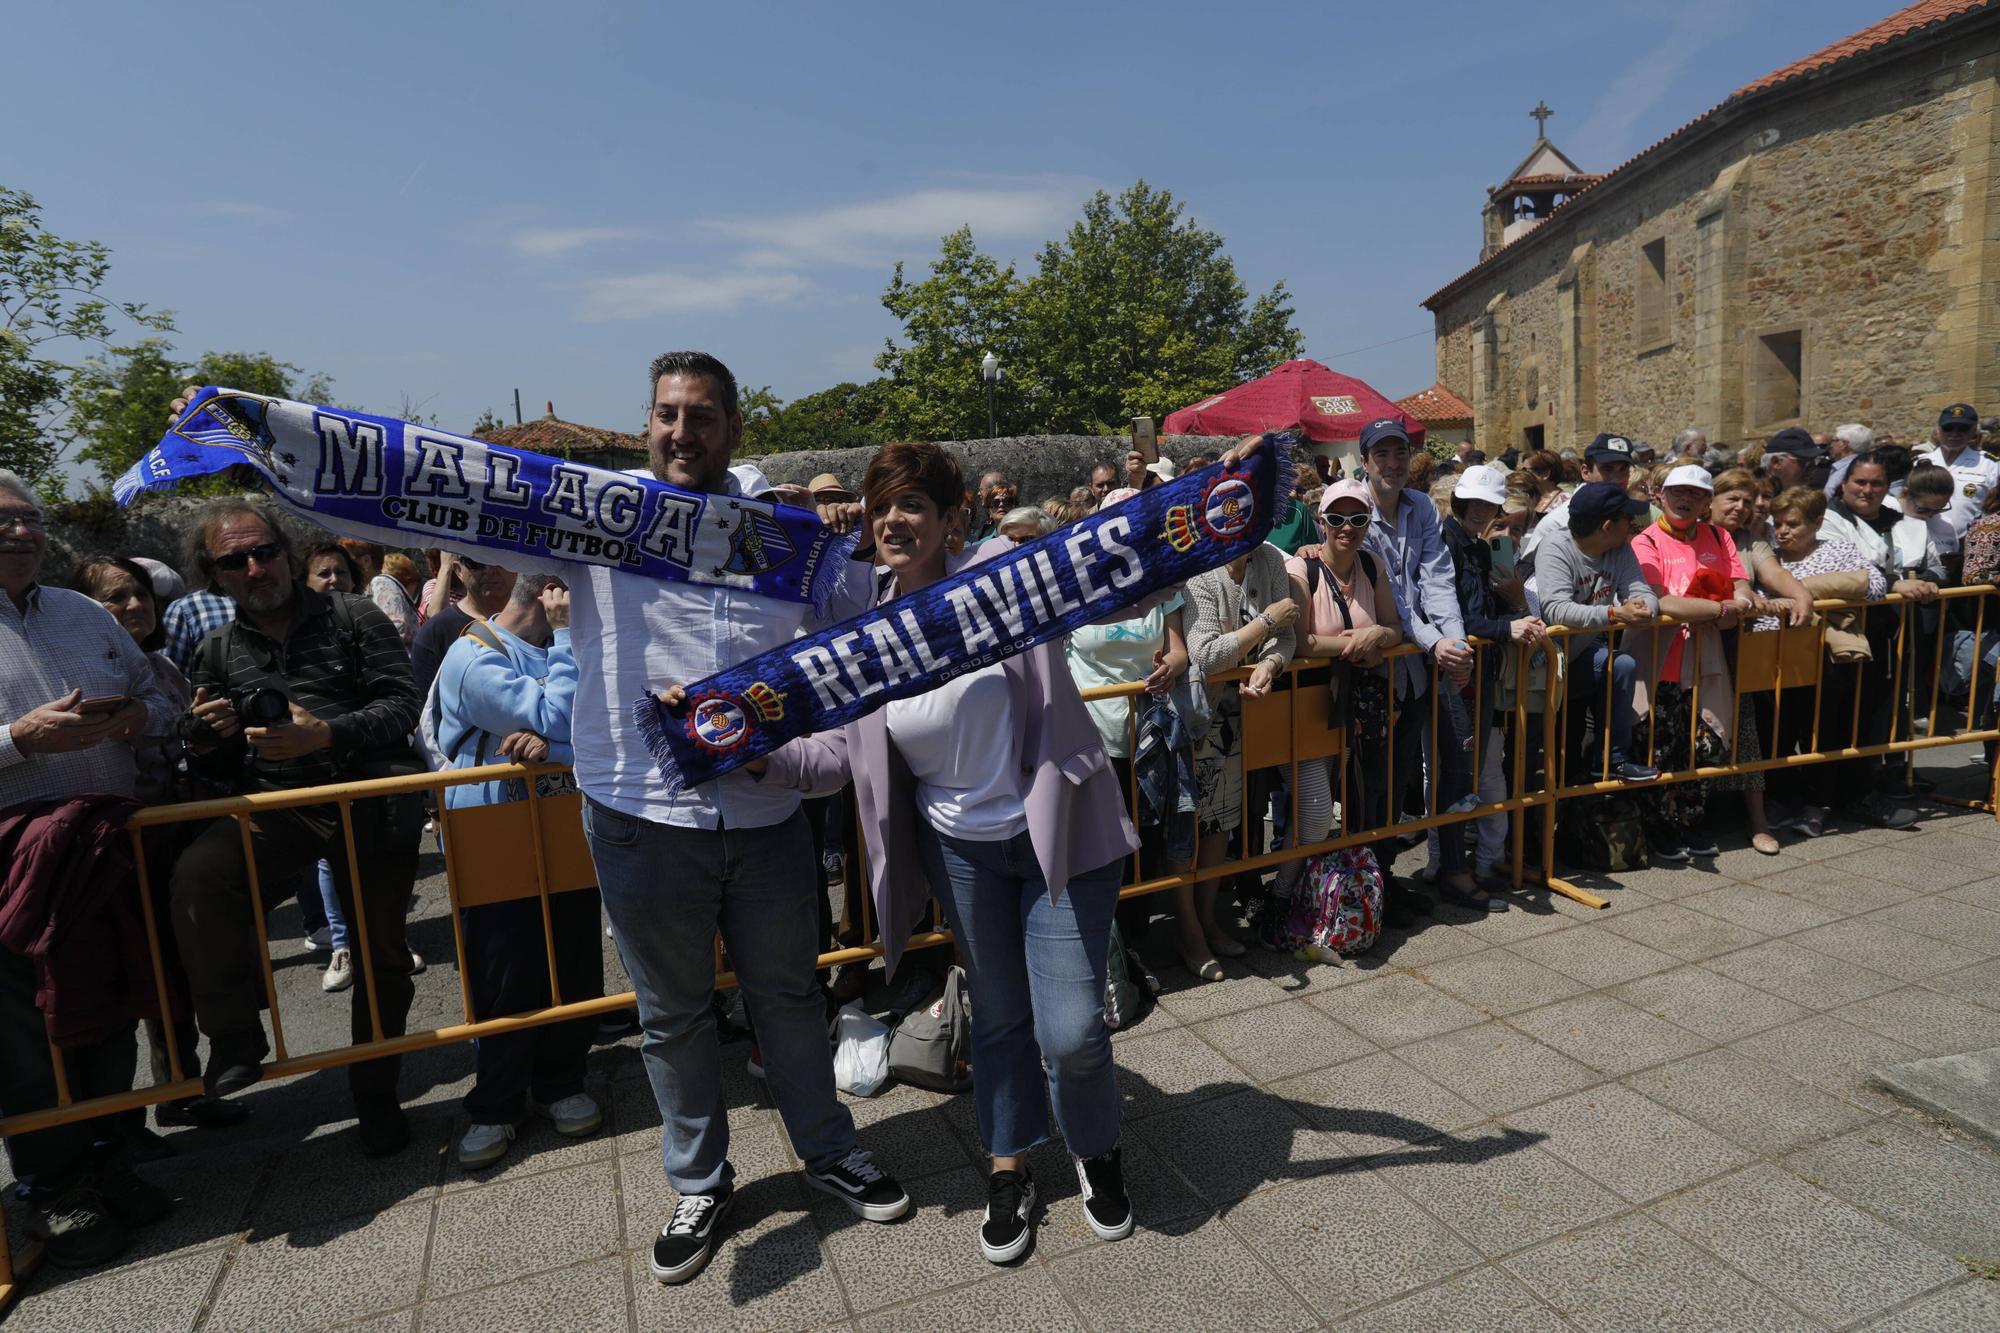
[876,180,1304,438]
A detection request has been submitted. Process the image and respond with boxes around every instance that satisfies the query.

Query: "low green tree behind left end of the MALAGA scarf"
[72,338,334,484]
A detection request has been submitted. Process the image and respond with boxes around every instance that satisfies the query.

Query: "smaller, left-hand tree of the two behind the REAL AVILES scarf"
[876,226,1040,440]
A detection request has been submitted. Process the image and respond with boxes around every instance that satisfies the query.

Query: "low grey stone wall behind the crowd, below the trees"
[42,434,1234,582]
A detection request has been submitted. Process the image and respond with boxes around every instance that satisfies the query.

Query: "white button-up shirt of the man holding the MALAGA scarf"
[566,476,876,829]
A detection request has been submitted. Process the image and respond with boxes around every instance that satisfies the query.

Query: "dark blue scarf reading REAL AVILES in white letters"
[632,436,1292,793]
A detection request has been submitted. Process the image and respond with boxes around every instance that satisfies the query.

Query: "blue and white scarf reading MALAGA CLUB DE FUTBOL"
[112,386,854,610]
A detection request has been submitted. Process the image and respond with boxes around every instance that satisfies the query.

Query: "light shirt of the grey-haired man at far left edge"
[0,586,180,809]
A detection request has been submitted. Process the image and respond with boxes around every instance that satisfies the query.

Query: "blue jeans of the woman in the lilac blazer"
[918,823,1124,1157]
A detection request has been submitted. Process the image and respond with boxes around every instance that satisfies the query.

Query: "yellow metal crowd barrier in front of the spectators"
[0,586,2000,1309]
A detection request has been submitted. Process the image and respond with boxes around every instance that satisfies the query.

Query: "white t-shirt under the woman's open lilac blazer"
[884,662,1028,843]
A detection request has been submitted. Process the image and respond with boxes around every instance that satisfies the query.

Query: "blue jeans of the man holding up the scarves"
[584,801,854,1195]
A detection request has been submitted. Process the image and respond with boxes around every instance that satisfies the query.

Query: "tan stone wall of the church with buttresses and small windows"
[1434,24,2000,452]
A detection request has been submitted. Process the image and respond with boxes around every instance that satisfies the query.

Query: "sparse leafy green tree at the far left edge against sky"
[0,186,174,480]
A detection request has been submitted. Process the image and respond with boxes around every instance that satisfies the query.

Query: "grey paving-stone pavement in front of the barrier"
[4,757,2000,1333]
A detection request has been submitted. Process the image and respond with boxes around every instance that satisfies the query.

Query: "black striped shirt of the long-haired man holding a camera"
[182,584,424,791]
